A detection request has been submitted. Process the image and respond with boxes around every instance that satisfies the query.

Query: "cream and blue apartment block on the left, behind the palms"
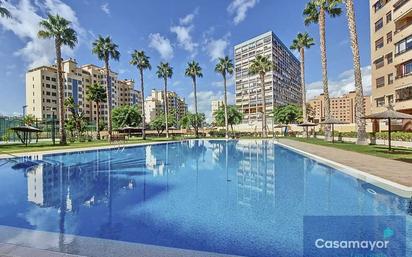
[26,59,142,121]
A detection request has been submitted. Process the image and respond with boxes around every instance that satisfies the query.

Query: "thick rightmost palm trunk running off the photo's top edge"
[345,0,368,145]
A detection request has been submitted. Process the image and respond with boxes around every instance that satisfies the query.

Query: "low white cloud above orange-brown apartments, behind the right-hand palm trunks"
[306,65,372,99]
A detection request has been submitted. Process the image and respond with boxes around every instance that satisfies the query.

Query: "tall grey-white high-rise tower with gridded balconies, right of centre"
[234,31,302,123]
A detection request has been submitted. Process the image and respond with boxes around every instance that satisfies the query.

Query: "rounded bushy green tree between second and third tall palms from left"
[113,105,142,128]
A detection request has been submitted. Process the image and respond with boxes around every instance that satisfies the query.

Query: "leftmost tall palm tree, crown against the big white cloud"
[38,14,77,145]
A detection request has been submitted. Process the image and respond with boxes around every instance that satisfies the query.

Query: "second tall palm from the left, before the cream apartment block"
[92,35,120,140]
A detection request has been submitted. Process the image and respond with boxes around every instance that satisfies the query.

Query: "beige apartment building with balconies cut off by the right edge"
[370,0,412,114]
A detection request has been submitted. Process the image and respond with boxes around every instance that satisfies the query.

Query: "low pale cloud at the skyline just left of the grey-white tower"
[188,90,235,122]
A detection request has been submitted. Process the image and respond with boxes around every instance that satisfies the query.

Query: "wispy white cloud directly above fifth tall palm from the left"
[170,9,199,57]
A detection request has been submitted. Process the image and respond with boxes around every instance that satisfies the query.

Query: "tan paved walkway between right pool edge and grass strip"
[278,139,412,187]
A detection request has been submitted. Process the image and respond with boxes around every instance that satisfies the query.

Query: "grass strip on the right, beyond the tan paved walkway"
[287,137,412,163]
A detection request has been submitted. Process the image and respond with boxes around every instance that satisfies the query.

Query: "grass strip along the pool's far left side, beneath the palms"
[0,137,180,154]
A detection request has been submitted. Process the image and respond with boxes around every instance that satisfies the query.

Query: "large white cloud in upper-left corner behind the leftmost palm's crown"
[0,0,85,67]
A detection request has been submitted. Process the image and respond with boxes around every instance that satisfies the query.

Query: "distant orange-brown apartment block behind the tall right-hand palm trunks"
[308,91,371,123]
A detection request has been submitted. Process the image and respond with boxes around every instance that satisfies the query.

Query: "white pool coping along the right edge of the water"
[274,141,412,198]
